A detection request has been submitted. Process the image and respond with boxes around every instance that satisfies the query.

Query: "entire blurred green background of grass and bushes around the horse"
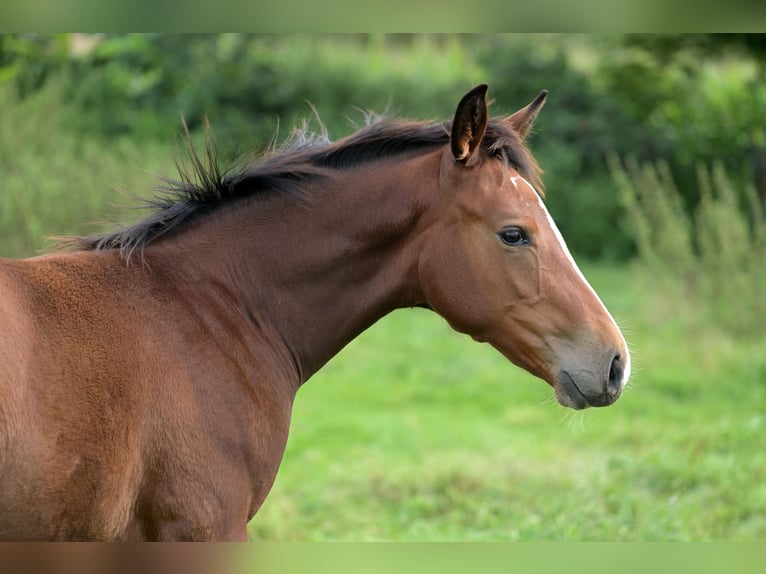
[0,34,766,540]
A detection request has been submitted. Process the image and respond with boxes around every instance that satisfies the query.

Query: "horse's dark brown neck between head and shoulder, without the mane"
[154,156,438,383]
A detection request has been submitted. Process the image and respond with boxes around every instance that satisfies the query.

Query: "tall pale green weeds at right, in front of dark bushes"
[610,156,766,335]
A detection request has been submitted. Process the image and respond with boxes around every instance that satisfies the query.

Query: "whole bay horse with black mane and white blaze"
[0,85,630,540]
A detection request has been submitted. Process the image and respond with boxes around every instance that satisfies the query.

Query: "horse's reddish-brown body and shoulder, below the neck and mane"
[0,252,290,540]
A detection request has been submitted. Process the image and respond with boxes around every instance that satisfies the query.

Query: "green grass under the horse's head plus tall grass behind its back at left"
[0,83,766,541]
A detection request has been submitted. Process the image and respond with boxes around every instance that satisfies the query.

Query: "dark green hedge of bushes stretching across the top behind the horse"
[0,34,766,260]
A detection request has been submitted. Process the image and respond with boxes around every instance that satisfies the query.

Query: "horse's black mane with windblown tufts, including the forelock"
[69,113,543,258]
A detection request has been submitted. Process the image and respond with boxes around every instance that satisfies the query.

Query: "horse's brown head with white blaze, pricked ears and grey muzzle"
[419,86,630,409]
